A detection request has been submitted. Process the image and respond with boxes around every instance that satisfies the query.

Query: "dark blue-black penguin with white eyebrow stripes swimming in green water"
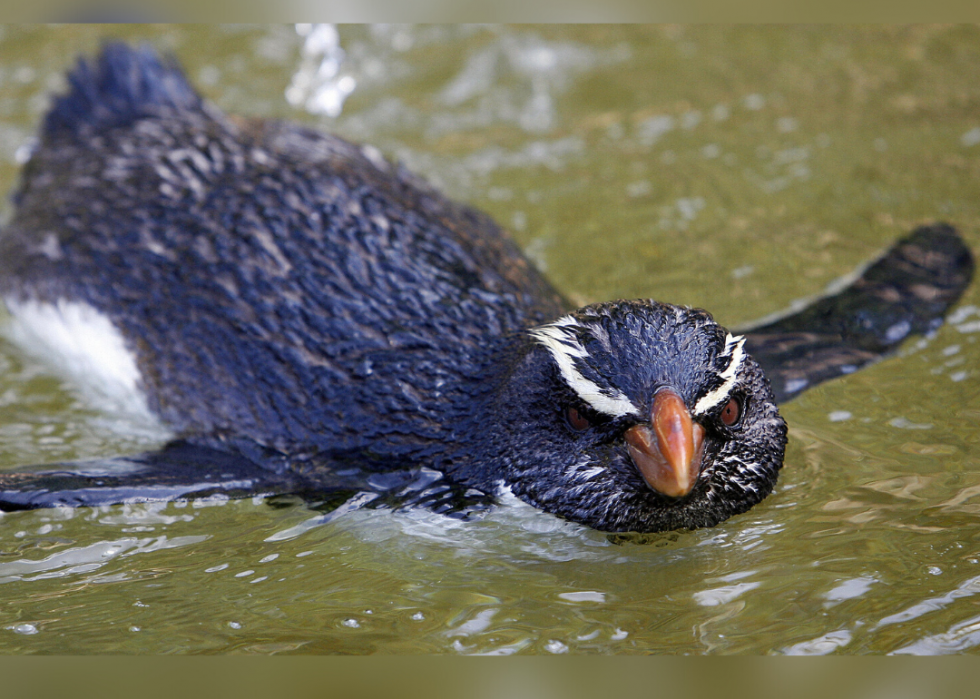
[0,43,973,532]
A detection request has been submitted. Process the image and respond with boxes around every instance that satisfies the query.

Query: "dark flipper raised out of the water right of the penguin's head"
[742,223,974,403]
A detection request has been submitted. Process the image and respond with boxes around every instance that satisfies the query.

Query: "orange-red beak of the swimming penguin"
[626,389,704,498]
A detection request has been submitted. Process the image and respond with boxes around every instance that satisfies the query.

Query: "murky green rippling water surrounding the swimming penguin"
[0,26,980,654]
